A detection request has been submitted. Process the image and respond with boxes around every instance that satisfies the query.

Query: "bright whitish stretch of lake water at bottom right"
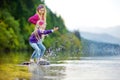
[63,60,120,80]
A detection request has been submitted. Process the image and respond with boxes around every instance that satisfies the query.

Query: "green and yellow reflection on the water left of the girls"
[0,53,32,80]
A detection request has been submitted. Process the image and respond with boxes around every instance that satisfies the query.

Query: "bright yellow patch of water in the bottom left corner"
[0,64,31,80]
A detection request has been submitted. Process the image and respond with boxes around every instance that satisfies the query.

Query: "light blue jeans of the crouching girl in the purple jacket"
[29,41,46,59]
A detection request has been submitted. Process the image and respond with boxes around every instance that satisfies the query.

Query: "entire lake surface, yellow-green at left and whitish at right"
[0,53,120,80]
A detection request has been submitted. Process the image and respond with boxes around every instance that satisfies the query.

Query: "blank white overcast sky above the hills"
[45,0,120,32]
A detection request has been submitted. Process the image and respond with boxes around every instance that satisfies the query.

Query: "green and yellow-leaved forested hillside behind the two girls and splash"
[0,0,81,51]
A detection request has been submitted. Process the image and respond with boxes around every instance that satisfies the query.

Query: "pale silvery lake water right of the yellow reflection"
[28,56,120,80]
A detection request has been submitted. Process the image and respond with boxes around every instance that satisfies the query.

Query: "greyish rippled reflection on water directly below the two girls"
[29,64,65,80]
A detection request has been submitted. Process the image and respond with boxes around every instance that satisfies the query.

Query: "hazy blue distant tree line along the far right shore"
[81,38,120,56]
